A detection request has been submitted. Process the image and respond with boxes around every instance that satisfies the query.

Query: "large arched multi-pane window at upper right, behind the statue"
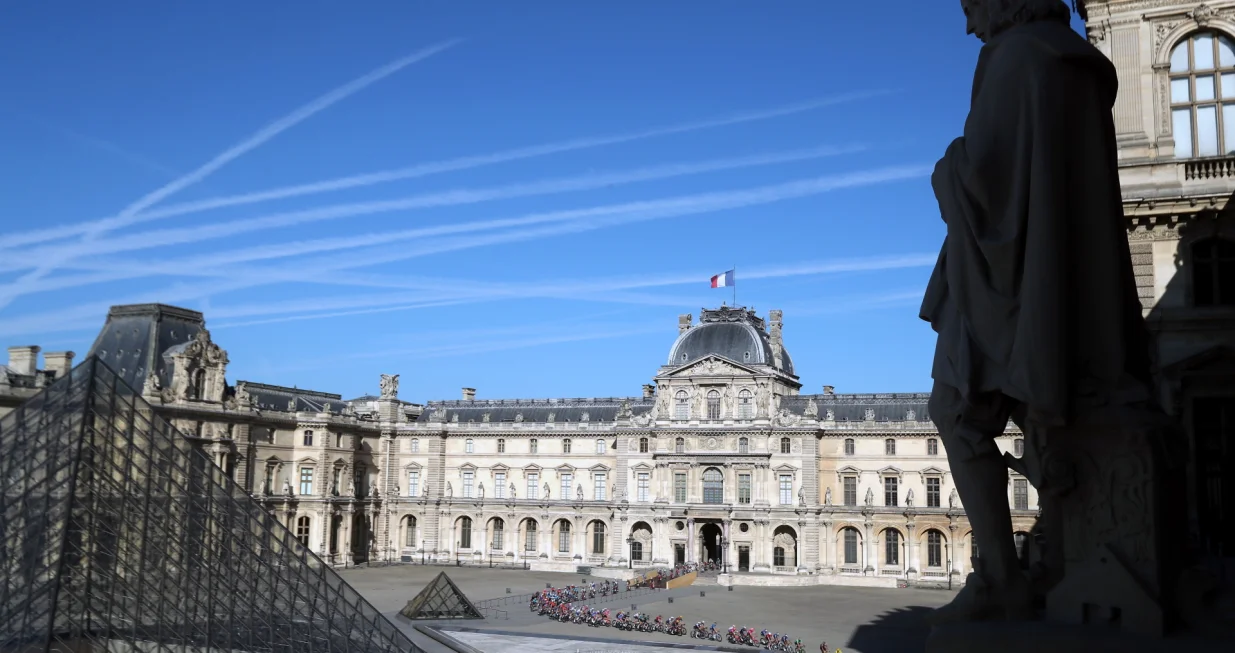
[1171,32,1235,158]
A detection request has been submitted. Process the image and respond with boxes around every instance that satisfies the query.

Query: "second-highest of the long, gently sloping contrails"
[0,146,866,271]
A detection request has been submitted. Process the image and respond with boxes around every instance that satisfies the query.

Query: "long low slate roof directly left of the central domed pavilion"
[416,396,653,423]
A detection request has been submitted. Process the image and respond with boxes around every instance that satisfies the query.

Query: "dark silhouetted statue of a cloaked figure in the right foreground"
[919,0,1152,623]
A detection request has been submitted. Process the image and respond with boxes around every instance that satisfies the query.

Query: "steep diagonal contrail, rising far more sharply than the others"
[0,40,461,309]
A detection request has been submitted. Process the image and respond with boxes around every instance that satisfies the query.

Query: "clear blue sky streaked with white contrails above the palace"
[0,0,1081,401]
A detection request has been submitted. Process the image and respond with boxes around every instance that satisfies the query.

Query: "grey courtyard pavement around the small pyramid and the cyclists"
[342,565,953,653]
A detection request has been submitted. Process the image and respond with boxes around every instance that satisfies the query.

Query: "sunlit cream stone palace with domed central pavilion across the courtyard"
[0,305,1037,586]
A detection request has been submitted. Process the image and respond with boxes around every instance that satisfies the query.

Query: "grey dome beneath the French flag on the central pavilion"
[668,307,793,374]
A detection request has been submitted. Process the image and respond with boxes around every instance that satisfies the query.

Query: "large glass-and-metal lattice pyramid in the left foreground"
[0,357,421,653]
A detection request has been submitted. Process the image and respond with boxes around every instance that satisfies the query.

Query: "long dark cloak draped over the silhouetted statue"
[920,21,1150,425]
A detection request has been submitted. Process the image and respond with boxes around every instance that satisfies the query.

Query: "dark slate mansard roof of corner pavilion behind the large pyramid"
[86,304,206,388]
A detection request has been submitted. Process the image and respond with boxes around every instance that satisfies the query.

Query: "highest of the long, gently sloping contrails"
[0,90,890,249]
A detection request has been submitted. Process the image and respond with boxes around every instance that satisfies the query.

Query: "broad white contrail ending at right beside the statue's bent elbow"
[0,160,929,299]
